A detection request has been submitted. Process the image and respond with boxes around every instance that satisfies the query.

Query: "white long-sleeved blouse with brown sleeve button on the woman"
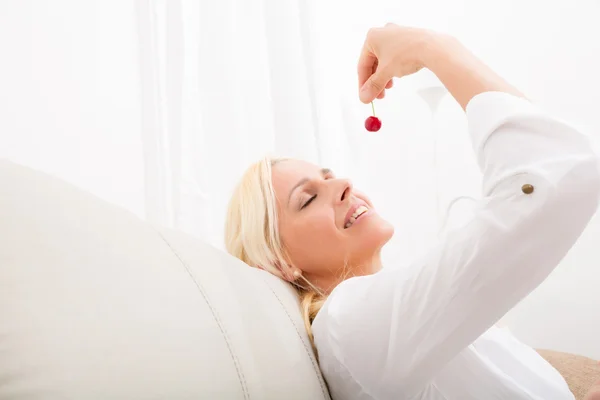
[313,92,600,400]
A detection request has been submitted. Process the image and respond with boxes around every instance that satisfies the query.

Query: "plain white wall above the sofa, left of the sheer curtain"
[0,0,144,215]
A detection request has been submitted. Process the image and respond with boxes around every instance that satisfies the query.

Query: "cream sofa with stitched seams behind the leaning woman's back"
[0,161,591,400]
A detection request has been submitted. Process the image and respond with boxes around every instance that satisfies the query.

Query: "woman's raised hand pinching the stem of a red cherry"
[358,24,432,103]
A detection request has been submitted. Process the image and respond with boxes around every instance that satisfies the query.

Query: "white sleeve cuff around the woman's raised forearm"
[465,92,545,166]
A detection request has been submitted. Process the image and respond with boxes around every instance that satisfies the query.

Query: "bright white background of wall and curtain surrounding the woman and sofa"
[0,0,600,359]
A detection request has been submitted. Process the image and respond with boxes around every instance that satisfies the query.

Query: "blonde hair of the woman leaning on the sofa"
[225,157,327,354]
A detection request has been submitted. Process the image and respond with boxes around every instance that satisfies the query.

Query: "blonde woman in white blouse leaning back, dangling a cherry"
[226,24,600,400]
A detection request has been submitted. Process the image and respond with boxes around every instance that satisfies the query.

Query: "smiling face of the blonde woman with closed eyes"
[272,160,394,291]
